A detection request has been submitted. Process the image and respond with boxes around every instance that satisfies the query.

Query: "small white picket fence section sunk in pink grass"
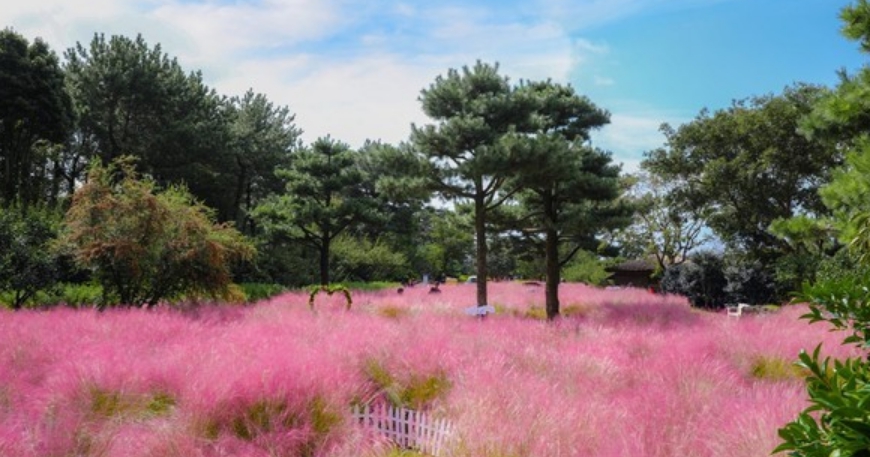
[352,403,453,457]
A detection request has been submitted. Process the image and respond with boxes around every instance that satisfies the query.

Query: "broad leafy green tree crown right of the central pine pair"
[642,85,842,265]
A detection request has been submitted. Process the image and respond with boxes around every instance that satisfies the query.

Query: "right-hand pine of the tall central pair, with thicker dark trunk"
[504,81,631,319]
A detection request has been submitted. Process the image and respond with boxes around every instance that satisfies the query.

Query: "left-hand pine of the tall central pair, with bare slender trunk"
[411,62,535,306]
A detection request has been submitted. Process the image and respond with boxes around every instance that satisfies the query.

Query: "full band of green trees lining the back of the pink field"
[0,4,862,318]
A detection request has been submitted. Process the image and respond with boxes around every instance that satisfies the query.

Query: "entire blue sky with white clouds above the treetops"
[0,0,865,171]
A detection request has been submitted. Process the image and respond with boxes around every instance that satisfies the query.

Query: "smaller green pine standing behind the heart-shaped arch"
[254,137,380,285]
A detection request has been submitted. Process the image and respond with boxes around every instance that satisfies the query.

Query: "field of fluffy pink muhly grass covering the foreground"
[0,283,850,457]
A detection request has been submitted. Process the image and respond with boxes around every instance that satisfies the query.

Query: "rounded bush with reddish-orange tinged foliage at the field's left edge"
[60,156,254,306]
